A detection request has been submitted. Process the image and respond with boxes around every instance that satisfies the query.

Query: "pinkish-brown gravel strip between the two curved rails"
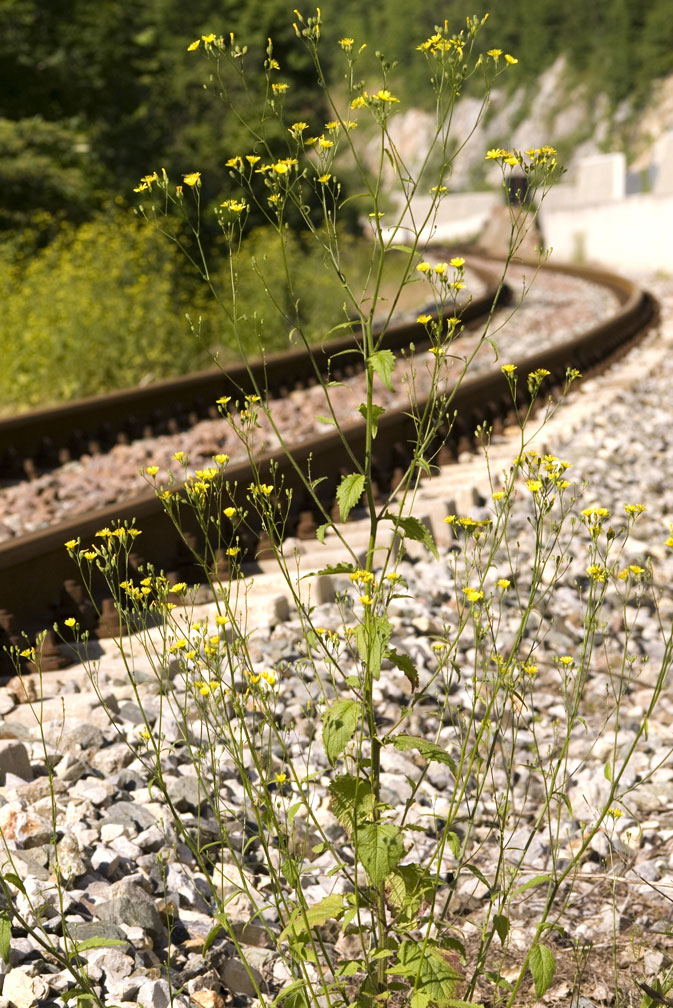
[0,268,617,541]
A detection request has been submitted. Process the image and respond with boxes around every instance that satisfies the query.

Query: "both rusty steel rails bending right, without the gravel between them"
[0,259,656,667]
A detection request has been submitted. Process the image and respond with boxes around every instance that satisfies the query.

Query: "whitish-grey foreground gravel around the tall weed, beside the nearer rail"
[0,279,673,1008]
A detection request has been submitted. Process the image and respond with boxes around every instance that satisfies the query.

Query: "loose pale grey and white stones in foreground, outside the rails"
[0,279,673,1008]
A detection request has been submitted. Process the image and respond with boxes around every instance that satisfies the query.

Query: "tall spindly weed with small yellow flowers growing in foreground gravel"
[1,11,673,1008]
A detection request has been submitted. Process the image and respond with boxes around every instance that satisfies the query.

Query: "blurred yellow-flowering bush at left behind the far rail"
[0,213,197,408]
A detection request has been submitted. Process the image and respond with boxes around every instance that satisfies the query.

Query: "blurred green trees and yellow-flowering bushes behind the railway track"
[0,0,673,412]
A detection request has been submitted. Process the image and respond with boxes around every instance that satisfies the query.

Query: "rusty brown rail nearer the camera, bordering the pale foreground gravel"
[0,265,656,667]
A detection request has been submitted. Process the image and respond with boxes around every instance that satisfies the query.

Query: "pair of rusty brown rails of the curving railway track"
[0,263,656,670]
